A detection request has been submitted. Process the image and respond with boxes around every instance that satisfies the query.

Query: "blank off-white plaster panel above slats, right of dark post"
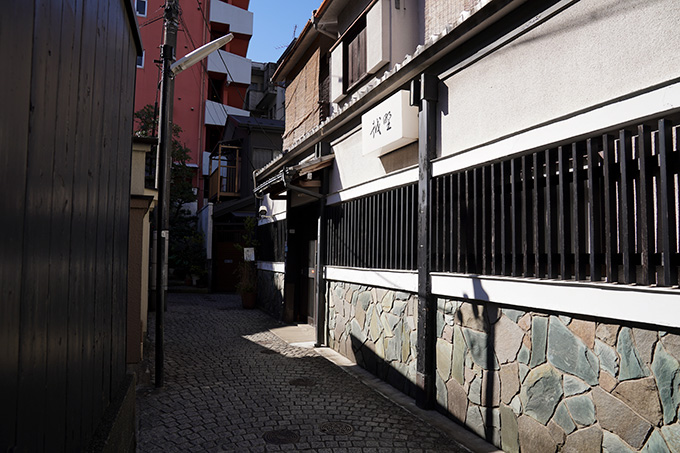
[439,0,680,155]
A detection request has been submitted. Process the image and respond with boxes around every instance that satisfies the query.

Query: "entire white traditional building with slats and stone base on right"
[255,0,680,452]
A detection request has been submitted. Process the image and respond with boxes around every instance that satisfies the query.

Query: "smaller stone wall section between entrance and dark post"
[326,282,417,394]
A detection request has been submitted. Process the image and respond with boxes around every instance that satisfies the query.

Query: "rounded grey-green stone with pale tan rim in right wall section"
[520,363,562,425]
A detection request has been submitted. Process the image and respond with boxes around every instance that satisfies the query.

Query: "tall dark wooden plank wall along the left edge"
[0,0,141,452]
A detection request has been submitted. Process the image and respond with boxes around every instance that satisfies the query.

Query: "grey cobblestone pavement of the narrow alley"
[137,294,468,452]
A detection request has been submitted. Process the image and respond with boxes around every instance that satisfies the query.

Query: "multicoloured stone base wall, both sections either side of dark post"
[327,282,680,453]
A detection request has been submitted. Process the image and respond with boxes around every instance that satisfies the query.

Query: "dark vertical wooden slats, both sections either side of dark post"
[328,115,680,286]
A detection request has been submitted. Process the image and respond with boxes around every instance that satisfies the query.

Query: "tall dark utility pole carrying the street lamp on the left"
[155,0,179,387]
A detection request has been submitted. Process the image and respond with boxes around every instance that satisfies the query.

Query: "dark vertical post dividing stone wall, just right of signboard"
[411,74,439,409]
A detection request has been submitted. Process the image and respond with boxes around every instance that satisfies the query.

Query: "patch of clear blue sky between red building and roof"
[247,0,322,63]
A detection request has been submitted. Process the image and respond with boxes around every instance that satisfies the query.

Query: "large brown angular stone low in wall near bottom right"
[591,387,652,450]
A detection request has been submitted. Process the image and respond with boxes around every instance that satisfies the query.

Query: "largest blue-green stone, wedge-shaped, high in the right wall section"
[548,316,600,385]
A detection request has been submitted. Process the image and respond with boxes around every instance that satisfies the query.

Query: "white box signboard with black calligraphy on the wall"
[361,90,418,156]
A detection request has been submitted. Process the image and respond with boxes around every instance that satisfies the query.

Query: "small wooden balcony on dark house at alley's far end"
[210,145,241,202]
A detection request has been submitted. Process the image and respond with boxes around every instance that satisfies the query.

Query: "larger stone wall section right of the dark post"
[436,299,680,453]
